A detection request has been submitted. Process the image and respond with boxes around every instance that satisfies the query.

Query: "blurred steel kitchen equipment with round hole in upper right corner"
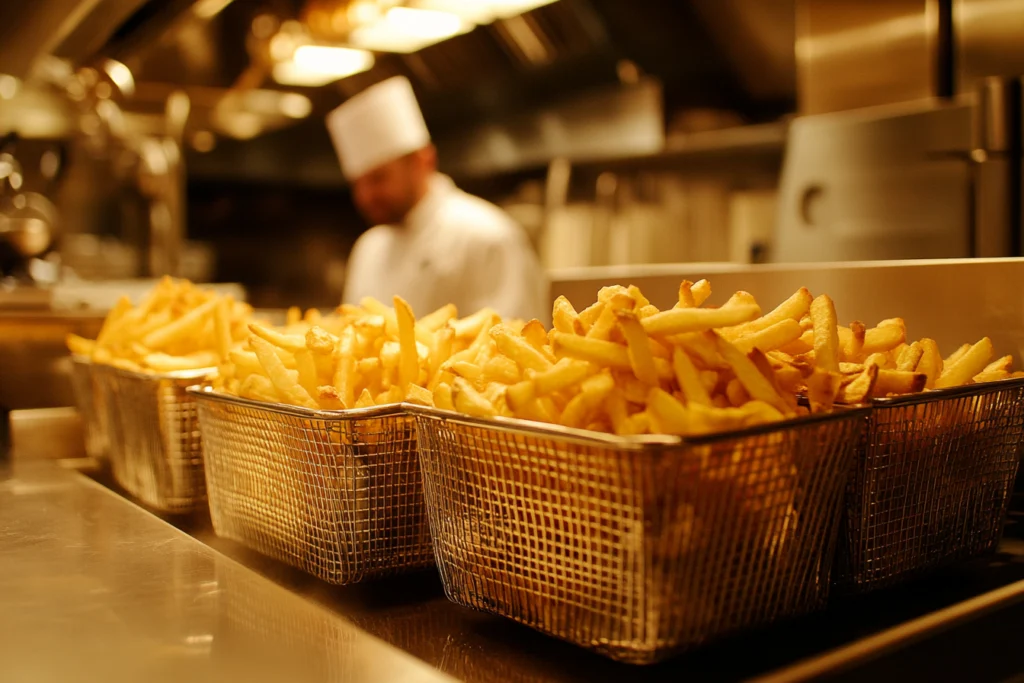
[773,0,1024,261]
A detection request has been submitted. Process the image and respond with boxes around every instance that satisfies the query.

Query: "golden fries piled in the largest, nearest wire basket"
[434,281,806,435]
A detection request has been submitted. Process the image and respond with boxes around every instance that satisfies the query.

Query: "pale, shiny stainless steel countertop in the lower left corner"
[0,460,451,683]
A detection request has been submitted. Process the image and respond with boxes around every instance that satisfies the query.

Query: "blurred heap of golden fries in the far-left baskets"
[67,278,252,373]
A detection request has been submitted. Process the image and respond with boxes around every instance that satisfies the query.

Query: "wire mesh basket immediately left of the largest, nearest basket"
[193,390,434,584]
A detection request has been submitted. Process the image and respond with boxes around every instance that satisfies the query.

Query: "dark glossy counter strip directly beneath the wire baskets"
[140,473,1024,683]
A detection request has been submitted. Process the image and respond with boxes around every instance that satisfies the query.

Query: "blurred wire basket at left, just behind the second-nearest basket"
[93,365,210,514]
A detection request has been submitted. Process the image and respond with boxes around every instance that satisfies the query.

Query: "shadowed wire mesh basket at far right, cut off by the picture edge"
[836,380,1024,593]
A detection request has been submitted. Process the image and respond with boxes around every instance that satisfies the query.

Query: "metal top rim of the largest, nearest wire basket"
[402,403,871,451]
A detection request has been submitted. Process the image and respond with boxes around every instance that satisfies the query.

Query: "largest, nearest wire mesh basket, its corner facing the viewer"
[409,408,865,664]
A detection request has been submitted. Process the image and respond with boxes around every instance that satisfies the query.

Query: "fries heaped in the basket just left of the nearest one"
[214,297,499,411]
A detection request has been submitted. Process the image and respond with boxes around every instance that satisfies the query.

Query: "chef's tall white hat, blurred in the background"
[327,76,430,180]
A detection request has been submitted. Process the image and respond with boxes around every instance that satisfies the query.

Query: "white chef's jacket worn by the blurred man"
[344,174,551,324]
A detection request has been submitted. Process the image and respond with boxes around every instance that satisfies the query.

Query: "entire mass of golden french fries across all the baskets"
[68,278,1022,435]
